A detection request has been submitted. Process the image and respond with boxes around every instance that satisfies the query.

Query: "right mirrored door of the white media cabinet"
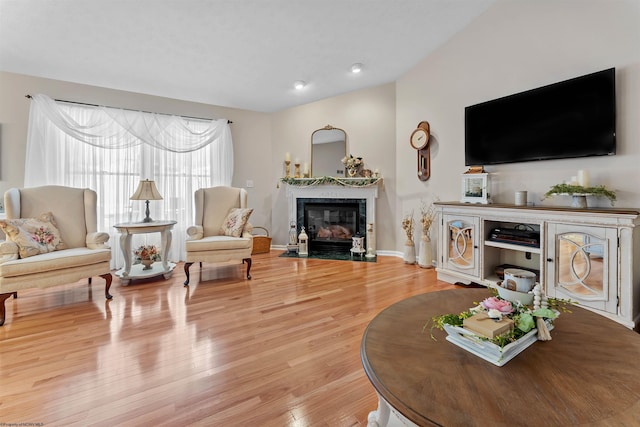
[550,225,617,312]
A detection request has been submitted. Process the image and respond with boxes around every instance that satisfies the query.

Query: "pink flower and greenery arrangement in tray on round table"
[423,285,574,347]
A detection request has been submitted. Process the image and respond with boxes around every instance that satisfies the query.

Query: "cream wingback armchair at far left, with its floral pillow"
[0,186,112,325]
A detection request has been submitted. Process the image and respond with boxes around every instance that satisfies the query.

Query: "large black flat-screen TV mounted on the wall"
[465,68,616,166]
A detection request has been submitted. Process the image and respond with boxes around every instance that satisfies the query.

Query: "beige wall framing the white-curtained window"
[0,72,272,231]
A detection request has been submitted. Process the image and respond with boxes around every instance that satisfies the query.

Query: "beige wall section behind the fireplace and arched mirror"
[271,83,399,250]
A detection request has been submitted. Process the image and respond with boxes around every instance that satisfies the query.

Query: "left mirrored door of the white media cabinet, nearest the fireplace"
[444,217,479,275]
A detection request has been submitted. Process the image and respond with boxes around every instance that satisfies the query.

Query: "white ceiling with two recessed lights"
[0,0,495,112]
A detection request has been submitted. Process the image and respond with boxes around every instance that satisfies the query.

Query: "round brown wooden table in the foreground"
[360,289,640,426]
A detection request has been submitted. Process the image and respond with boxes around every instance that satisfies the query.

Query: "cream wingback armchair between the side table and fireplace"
[184,186,253,286]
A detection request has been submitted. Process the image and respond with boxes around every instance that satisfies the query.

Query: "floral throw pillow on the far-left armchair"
[0,212,66,258]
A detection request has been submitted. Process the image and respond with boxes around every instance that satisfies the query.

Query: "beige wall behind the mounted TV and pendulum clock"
[396,0,640,252]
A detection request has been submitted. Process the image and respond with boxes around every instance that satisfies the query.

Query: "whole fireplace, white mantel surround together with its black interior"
[287,179,381,254]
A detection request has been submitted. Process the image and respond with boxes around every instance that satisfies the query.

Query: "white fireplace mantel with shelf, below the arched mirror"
[282,178,382,254]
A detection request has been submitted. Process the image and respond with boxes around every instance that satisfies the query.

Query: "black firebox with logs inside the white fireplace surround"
[296,198,367,252]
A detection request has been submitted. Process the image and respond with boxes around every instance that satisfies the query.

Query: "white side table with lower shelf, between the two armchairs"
[113,220,176,286]
